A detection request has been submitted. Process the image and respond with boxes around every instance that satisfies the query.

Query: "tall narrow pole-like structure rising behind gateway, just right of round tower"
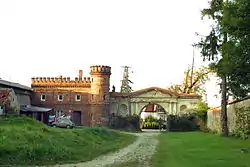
[121,66,133,93]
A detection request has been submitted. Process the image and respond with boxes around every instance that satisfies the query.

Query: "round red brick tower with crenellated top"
[89,66,111,126]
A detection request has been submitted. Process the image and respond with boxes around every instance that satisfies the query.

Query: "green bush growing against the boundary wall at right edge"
[232,107,250,139]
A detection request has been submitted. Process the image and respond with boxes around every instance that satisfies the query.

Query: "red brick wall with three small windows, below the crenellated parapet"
[32,88,90,125]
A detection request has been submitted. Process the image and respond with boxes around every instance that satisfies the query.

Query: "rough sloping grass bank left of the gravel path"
[0,116,136,166]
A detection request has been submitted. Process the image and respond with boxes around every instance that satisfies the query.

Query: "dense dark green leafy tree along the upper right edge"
[223,0,250,98]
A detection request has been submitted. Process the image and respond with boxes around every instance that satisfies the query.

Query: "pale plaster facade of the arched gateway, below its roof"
[110,91,199,116]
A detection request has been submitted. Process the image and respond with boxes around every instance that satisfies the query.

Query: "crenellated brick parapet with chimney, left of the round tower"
[31,70,91,87]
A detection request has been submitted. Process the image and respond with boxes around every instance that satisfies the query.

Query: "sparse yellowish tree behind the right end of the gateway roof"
[168,67,211,95]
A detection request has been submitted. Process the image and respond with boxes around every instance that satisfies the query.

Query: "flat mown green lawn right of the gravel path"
[150,132,250,167]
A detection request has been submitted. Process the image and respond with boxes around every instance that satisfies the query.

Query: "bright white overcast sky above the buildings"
[0,0,219,106]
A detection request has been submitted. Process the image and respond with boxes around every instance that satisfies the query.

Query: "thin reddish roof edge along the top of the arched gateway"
[111,87,201,98]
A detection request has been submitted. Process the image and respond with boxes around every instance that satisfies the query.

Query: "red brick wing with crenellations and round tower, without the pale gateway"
[31,66,111,125]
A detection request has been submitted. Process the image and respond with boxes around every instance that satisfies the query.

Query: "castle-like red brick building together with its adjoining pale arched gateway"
[31,66,201,126]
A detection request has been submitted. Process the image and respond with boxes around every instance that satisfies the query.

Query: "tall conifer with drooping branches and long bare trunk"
[197,0,230,136]
